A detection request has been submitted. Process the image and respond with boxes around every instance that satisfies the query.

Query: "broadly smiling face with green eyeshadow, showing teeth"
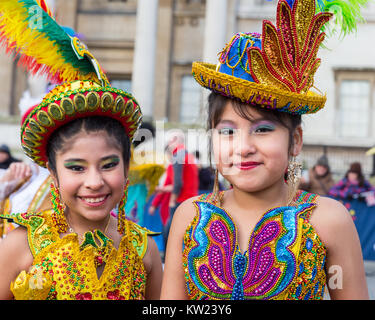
[51,131,126,222]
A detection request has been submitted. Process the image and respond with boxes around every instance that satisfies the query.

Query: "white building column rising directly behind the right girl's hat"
[203,0,228,64]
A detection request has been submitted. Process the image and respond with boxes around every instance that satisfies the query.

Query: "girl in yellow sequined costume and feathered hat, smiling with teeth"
[0,0,162,300]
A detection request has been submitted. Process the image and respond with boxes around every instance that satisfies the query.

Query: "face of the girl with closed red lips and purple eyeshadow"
[212,100,302,192]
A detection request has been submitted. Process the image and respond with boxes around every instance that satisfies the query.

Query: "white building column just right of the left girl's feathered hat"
[132,0,158,120]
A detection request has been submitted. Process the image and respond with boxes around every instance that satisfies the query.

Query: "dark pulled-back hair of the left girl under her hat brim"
[47,116,130,173]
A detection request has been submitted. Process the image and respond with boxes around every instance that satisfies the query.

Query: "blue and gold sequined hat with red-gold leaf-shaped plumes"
[192,0,367,114]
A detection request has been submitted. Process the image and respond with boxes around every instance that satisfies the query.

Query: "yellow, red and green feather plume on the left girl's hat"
[0,0,109,85]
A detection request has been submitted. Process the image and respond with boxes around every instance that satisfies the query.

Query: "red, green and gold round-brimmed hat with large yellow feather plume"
[0,0,142,167]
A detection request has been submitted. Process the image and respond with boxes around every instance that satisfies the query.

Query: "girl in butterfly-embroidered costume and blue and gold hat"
[161,0,368,300]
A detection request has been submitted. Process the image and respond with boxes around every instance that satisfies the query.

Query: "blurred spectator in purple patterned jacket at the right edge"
[328,162,375,200]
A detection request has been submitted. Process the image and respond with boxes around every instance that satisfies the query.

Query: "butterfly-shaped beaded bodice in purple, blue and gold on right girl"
[183,193,326,300]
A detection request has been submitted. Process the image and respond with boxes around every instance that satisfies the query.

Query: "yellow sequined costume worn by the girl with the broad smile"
[1,210,153,300]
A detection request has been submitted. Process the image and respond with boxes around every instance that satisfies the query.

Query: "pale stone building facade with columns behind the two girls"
[0,0,375,175]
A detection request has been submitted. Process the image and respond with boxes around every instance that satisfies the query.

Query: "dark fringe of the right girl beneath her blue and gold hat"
[207,92,302,165]
